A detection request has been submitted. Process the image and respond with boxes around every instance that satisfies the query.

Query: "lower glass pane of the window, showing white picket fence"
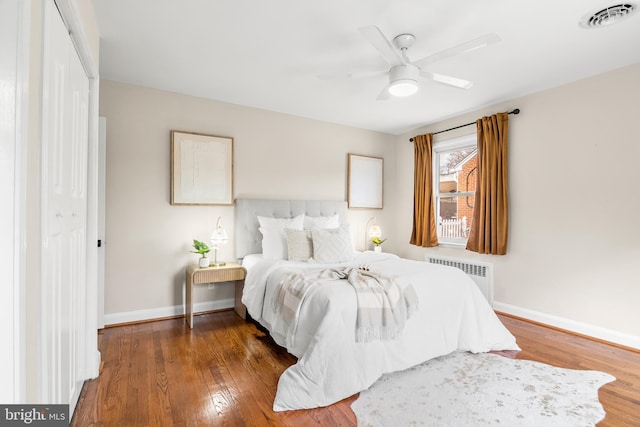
[438,196,475,239]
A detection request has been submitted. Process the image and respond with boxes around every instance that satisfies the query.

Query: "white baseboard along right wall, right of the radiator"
[493,301,640,350]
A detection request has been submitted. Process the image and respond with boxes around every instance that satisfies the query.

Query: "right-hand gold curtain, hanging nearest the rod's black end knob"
[467,113,509,255]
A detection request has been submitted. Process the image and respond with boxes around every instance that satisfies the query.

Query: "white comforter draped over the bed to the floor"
[242,252,519,411]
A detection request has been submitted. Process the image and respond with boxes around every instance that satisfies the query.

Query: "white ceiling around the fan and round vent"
[94,0,640,134]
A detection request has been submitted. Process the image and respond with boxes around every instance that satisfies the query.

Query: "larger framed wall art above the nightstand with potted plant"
[171,130,233,205]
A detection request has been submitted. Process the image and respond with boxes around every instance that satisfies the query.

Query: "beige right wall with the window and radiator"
[394,65,640,343]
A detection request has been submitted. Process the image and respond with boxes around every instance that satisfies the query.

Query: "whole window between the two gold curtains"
[433,134,478,245]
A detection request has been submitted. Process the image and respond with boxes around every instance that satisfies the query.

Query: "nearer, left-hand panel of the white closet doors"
[40,2,69,403]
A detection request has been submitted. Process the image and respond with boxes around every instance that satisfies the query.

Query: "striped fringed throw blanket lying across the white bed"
[274,267,418,342]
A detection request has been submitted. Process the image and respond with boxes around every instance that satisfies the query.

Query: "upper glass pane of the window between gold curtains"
[438,148,478,194]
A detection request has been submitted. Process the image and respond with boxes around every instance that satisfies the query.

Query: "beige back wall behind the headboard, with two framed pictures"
[100,80,395,324]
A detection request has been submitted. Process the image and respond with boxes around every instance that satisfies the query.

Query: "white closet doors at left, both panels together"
[41,2,89,411]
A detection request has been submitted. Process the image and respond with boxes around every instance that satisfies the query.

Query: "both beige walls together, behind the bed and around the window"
[100,65,640,344]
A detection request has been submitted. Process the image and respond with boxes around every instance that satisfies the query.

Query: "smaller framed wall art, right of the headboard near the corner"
[347,153,383,209]
